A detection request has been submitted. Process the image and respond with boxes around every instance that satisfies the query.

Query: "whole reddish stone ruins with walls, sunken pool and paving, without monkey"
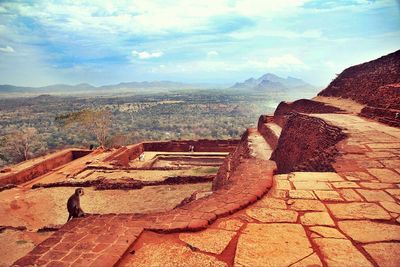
[0,51,400,266]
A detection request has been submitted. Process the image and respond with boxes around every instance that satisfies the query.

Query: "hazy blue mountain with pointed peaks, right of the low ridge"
[230,73,315,91]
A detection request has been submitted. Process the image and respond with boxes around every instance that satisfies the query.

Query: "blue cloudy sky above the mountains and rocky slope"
[0,0,400,87]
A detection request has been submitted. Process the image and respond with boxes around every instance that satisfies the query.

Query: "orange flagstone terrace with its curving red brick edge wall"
[15,114,400,266]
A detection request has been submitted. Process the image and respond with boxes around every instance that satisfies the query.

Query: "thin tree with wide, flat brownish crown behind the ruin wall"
[56,109,112,147]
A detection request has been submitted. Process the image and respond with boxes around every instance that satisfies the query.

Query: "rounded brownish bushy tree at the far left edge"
[4,127,42,162]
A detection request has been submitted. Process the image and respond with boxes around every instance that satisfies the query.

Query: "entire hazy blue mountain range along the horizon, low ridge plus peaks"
[0,73,315,94]
